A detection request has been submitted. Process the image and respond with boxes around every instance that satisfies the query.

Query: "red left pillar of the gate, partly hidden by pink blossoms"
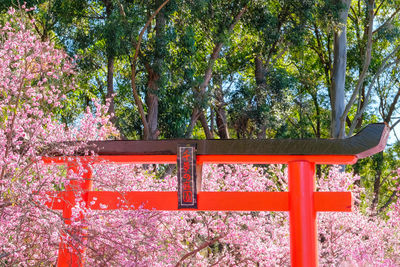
[57,163,93,267]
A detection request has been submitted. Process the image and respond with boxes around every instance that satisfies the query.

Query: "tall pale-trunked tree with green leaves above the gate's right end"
[314,0,400,138]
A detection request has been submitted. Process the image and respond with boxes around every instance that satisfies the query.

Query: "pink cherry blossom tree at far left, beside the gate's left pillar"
[0,7,113,266]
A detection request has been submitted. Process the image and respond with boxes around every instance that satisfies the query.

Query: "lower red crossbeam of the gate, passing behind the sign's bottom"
[46,191,352,212]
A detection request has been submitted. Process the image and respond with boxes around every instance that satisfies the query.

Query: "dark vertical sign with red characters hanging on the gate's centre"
[177,144,197,209]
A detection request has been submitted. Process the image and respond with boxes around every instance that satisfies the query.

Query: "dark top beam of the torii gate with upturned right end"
[79,123,390,158]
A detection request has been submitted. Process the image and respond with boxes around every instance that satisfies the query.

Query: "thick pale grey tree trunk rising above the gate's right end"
[330,0,351,138]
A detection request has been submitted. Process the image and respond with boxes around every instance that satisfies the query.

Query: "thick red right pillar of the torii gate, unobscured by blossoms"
[289,161,318,267]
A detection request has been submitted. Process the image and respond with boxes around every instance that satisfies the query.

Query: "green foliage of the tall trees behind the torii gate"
[4,0,400,209]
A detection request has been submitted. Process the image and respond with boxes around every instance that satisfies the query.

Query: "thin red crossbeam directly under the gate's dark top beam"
[42,155,357,164]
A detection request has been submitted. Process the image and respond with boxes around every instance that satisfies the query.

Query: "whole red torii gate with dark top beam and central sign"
[43,123,390,267]
